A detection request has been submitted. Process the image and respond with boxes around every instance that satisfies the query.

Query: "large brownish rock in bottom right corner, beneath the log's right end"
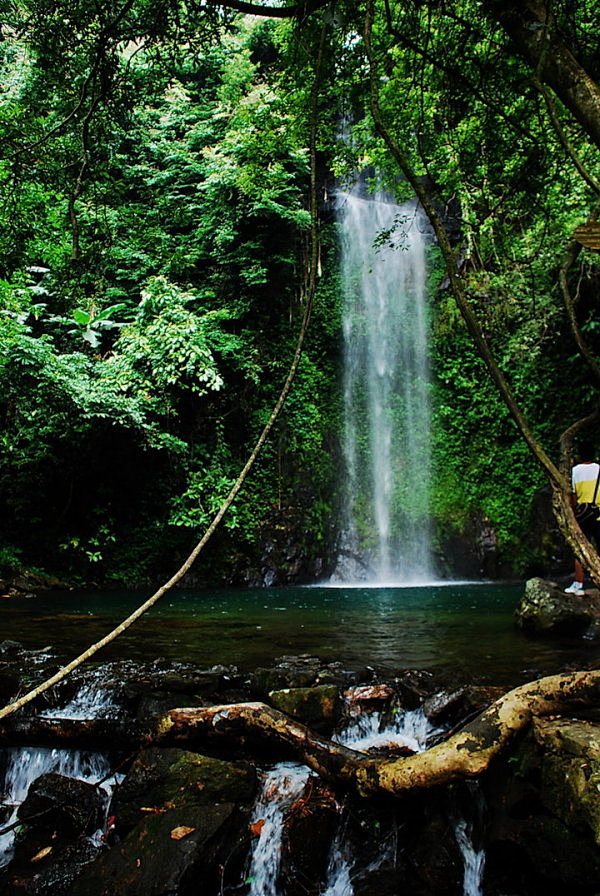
[485,719,600,896]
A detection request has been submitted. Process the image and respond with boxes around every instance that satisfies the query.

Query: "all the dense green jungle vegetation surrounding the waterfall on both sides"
[0,0,600,584]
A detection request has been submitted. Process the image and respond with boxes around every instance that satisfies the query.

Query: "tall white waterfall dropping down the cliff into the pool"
[336,190,432,584]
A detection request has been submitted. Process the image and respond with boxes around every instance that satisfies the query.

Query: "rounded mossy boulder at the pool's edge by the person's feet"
[515,578,600,638]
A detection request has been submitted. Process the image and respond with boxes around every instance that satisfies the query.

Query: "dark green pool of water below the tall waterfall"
[0,583,600,684]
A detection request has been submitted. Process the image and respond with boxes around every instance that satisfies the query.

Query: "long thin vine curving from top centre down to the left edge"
[0,19,325,719]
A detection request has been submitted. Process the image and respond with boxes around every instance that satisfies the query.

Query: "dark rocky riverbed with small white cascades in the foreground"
[0,643,600,896]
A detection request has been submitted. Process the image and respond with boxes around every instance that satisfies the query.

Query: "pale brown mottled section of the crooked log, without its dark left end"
[161,671,600,796]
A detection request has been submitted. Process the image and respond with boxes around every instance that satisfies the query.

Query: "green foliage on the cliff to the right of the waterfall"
[328,0,600,570]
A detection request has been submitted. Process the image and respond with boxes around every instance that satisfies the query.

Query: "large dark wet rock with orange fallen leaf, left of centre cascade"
[70,748,255,896]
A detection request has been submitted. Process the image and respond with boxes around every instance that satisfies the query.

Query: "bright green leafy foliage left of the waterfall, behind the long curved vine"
[0,10,340,580]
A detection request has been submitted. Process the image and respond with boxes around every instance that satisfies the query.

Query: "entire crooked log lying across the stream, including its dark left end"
[0,670,600,796]
